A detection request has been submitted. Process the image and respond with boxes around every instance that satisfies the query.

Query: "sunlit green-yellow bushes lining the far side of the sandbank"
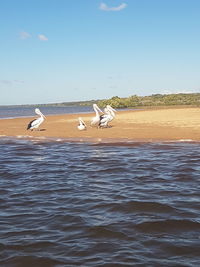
[98,93,200,108]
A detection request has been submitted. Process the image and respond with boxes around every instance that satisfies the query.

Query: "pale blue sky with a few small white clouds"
[0,0,200,105]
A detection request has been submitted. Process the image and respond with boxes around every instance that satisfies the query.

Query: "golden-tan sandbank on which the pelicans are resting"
[0,108,200,142]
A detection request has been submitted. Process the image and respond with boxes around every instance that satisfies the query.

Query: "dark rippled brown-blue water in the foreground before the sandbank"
[0,138,200,267]
